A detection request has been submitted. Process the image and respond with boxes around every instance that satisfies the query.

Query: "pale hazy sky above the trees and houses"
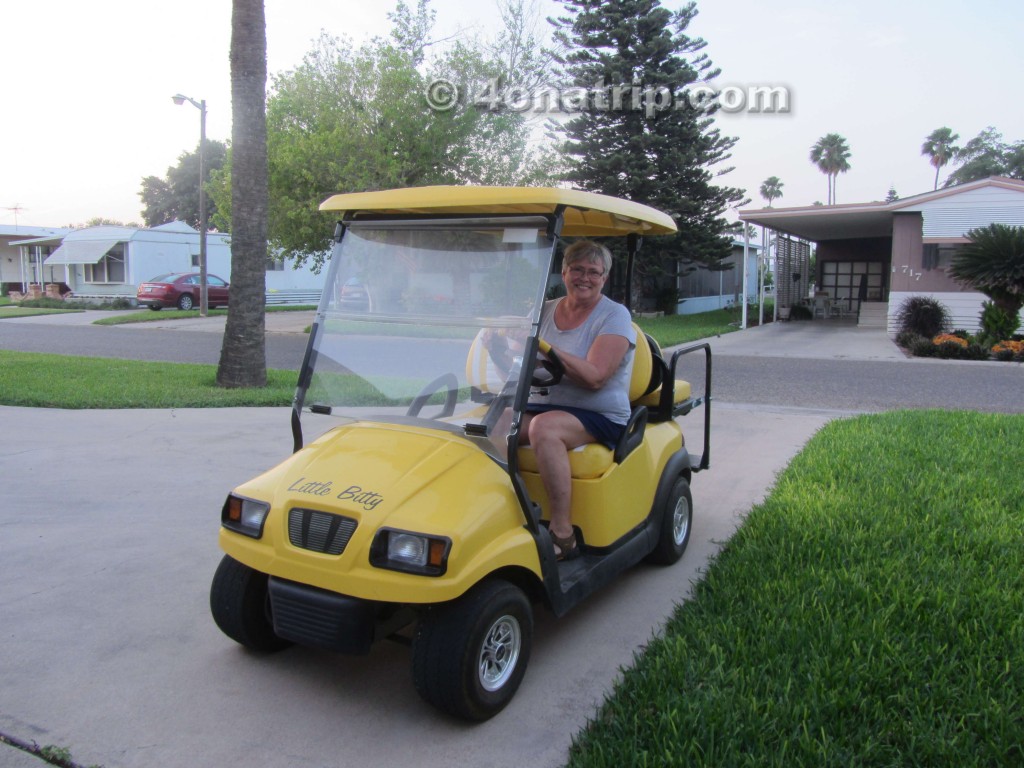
[0,0,1024,226]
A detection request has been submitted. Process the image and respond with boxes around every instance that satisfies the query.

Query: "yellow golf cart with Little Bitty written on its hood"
[210,186,711,720]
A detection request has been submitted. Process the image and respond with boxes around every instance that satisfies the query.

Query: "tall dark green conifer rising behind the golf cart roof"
[549,0,744,288]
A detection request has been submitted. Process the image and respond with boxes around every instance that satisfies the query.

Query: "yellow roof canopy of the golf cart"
[321,186,676,238]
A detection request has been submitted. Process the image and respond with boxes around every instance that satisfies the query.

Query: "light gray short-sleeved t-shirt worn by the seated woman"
[529,296,636,424]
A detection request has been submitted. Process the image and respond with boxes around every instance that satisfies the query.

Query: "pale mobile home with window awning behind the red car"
[10,221,324,303]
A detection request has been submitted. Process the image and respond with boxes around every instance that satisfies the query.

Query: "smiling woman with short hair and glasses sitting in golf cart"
[520,241,636,559]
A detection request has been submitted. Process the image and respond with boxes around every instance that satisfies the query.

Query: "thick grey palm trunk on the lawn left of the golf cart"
[217,0,268,387]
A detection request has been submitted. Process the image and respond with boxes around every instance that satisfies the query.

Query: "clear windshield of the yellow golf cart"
[296,216,554,450]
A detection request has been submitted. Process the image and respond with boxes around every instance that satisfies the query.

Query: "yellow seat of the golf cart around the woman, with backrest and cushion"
[519,323,690,480]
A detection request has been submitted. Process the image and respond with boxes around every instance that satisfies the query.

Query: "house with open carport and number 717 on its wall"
[739,176,1024,333]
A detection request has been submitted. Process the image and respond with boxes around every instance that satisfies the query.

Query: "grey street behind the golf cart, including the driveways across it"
[0,310,1024,413]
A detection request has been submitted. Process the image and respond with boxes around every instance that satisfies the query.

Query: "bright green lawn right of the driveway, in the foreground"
[569,412,1024,768]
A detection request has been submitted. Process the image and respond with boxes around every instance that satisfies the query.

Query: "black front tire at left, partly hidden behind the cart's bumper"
[210,555,291,653]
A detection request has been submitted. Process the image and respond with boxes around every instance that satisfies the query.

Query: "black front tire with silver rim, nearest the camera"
[413,581,534,721]
